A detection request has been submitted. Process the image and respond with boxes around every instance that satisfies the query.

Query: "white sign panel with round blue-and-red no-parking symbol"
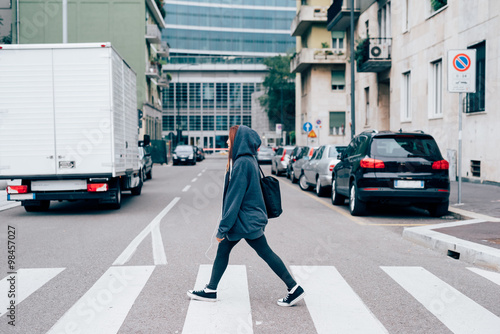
[448,49,476,93]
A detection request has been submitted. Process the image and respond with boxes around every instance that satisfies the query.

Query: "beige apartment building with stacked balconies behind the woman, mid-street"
[290,0,350,145]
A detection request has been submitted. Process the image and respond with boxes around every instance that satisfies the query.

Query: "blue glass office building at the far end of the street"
[163,0,296,148]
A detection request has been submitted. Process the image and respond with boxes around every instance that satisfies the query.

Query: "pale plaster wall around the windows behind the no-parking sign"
[390,0,500,182]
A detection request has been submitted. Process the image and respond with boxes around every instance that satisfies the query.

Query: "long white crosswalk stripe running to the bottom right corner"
[381,267,500,334]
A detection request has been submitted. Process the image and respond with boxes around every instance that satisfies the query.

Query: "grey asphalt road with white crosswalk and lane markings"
[0,157,500,334]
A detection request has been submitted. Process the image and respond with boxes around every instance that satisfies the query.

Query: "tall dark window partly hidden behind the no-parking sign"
[465,42,486,113]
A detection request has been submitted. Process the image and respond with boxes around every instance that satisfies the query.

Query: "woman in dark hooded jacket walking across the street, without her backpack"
[187,125,304,306]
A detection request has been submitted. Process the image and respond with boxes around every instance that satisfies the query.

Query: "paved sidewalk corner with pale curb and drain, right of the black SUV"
[403,182,500,271]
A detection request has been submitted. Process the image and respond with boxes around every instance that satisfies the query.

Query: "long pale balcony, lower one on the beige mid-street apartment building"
[290,49,347,73]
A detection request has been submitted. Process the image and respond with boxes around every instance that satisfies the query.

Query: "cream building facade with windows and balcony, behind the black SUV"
[322,0,500,182]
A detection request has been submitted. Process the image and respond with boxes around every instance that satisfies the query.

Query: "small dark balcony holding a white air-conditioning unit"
[356,38,392,73]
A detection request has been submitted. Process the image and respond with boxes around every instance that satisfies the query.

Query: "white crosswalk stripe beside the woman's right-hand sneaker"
[291,266,387,334]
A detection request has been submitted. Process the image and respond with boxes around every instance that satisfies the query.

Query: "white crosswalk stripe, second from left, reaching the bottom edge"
[47,266,155,334]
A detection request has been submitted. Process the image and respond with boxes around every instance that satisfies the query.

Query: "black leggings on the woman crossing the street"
[207,235,297,290]
